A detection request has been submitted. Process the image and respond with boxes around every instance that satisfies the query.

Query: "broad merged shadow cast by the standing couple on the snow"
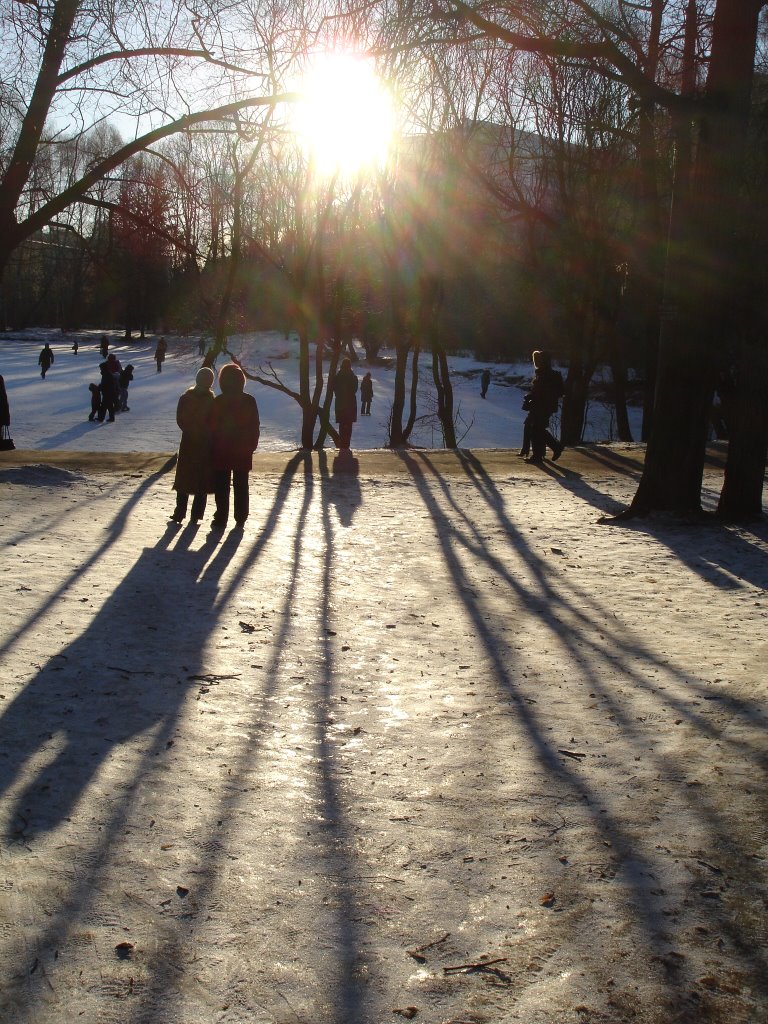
[0,535,228,842]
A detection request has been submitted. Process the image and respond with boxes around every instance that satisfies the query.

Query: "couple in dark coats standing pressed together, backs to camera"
[171,362,259,529]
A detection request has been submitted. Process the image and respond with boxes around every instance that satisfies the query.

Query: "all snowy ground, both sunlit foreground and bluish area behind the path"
[0,327,768,1024]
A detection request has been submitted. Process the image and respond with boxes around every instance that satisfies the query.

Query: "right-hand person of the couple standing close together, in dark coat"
[204,362,260,529]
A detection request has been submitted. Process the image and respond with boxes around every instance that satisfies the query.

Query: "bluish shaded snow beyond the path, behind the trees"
[0,331,640,452]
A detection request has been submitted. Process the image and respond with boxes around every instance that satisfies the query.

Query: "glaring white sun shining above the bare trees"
[295,52,394,177]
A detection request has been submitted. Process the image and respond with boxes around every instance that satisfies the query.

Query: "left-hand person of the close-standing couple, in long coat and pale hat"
[171,367,214,522]
